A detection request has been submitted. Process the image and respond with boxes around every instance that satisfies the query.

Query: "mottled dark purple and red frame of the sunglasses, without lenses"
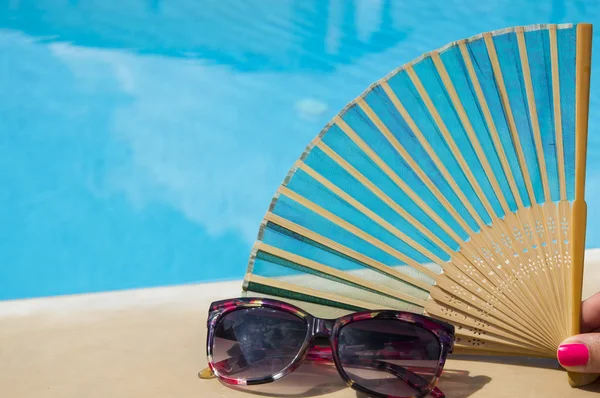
[206,297,454,398]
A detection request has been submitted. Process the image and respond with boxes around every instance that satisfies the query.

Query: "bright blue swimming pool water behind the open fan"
[0,0,600,299]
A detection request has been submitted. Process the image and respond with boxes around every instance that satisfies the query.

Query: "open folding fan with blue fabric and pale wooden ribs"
[243,24,592,385]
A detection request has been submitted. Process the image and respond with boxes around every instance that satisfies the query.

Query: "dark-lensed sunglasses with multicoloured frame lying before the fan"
[200,298,454,398]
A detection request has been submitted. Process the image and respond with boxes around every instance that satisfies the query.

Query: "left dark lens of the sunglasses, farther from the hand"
[212,307,308,380]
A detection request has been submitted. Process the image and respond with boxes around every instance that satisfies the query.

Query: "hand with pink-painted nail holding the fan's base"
[558,292,600,373]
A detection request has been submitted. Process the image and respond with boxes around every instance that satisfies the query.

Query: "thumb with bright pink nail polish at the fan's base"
[557,333,600,373]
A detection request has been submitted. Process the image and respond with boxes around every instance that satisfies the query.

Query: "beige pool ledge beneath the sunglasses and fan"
[0,250,600,398]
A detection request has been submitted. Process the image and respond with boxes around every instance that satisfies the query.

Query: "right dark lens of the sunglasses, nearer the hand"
[338,319,441,397]
